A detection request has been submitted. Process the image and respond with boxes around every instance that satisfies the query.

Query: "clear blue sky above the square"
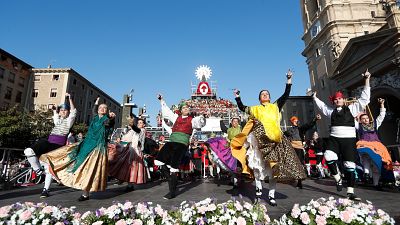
[0,0,310,125]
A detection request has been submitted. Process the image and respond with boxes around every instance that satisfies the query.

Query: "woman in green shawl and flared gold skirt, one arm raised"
[40,98,115,201]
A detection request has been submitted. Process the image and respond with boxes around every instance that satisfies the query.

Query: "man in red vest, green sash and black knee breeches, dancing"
[154,95,206,199]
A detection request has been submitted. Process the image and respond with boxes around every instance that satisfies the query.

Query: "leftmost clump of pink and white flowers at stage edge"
[0,202,80,225]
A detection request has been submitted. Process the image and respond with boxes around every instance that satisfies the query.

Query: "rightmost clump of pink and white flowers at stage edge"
[274,197,395,225]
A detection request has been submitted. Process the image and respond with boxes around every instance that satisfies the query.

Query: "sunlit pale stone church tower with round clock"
[300,0,386,136]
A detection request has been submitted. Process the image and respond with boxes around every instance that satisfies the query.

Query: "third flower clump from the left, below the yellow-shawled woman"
[170,198,270,225]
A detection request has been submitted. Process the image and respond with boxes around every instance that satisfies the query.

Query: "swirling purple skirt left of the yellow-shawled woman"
[207,137,237,172]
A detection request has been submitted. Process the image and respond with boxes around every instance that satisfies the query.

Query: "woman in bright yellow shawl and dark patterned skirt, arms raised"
[231,70,306,206]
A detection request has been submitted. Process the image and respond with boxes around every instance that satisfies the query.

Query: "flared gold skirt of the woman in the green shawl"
[39,144,108,192]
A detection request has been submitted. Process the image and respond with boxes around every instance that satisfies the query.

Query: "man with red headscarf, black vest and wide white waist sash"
[313,70,371,200]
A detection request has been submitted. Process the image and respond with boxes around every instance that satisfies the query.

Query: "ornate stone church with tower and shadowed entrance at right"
[301,0,400,148]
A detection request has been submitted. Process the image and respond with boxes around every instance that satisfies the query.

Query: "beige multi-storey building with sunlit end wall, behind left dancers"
[30,68,122,127]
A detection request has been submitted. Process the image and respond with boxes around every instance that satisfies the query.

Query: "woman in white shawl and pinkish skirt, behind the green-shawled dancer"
[108,118,148,191]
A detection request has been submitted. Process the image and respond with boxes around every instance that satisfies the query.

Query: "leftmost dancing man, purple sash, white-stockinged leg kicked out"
[24,93,76,198]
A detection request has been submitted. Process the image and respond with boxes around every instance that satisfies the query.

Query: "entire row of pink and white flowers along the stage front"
[0,197,395,225]
